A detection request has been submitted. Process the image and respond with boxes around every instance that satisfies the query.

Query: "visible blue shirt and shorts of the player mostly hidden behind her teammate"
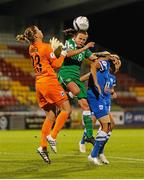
[105,72,116,111]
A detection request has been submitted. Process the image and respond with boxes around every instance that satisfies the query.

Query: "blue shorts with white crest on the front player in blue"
[87,90,108,119]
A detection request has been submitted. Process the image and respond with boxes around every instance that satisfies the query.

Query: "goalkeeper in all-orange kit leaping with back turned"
[16,26,71,163]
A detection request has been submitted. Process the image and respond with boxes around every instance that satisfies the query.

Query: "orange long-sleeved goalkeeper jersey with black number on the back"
[29,42,64,80]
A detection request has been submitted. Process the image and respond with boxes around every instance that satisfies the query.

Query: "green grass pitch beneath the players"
[0,129,144,179]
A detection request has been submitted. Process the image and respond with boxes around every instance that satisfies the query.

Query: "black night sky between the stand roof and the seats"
[66,1,144,67]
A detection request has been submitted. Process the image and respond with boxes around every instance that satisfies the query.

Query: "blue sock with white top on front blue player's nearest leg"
[91,130,107,157]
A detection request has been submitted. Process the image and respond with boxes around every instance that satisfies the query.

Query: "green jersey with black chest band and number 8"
[59,39,92,78]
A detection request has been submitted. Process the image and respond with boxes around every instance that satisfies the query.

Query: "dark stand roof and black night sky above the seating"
[0,0,144,66]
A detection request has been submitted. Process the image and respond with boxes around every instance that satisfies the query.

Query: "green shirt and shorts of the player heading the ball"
[58,39,92,99]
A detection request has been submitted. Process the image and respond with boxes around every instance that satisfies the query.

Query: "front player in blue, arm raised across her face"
[79,55,120,165]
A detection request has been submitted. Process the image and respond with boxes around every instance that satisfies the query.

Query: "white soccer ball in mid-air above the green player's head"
[73,16,89,31]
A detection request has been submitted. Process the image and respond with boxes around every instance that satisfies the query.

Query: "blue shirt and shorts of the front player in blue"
[87,61,110,119]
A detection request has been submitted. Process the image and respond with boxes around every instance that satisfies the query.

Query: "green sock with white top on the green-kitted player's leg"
[83,111,93,138]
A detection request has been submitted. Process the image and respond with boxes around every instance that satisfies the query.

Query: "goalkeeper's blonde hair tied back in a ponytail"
[16,26,36,43]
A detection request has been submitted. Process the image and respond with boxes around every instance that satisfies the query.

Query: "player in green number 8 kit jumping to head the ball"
[58,30,97,144]
